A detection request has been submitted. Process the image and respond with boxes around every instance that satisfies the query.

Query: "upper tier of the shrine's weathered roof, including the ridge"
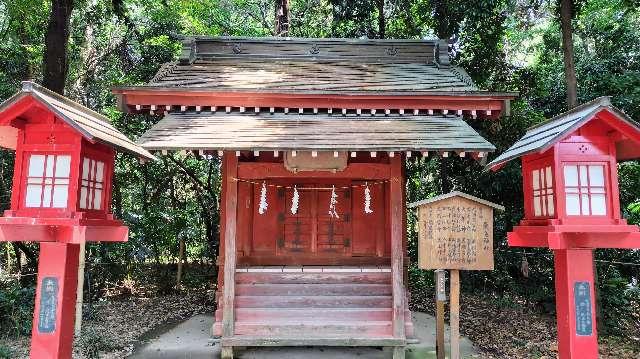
[132,37,478,93]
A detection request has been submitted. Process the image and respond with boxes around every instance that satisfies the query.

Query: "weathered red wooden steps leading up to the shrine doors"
[213,270,413,346]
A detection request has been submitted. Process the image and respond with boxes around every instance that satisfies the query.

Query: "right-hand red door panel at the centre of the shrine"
[316,188,351,255]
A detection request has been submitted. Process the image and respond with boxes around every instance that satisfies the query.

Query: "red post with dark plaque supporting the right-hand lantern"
[554,249,598,359]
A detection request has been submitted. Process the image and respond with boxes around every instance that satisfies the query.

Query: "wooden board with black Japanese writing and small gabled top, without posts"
[411,192,503,270]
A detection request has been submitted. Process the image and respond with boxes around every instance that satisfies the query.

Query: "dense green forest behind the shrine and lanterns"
[0,0,640,358]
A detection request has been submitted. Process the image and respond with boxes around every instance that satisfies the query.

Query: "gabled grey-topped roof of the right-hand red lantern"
[486,97,640,170]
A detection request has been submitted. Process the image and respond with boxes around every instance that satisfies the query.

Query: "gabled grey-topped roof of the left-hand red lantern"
[0,81,155,159]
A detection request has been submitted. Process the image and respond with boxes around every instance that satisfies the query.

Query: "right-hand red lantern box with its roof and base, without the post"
[488,97,640,248]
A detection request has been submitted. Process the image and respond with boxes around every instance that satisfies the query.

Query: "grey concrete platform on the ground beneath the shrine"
[129,312,477,359]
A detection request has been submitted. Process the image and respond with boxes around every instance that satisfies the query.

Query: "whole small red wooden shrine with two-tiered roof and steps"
[113,37,515,358]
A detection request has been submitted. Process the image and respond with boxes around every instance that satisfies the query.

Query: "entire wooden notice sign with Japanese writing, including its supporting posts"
[409,192,504,359]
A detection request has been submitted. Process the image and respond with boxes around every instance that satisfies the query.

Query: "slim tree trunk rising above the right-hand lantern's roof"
[560,0,578,109]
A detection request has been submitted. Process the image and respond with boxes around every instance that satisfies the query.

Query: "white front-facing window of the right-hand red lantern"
[564,164,607,216]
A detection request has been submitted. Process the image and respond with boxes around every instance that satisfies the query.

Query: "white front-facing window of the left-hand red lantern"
[25,154,71,208]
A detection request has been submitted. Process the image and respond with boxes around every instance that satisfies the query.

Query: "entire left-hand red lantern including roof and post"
[0,82,153,359]
